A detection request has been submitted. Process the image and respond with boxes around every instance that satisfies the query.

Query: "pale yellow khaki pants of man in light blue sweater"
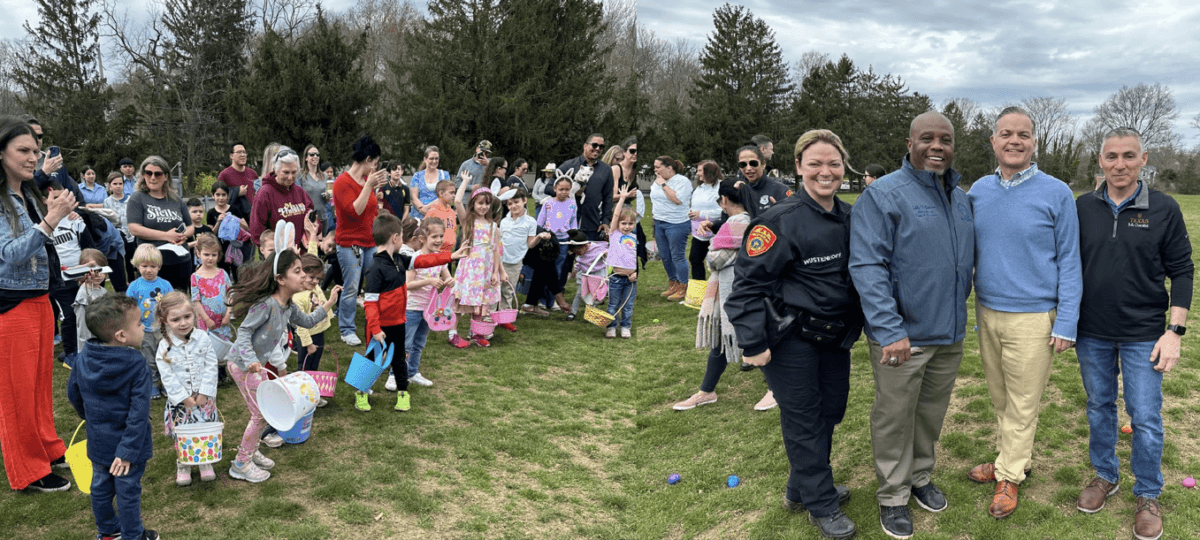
[976,300,1055,484]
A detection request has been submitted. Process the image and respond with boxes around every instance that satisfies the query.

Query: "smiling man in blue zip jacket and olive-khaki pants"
[850,112,974,539]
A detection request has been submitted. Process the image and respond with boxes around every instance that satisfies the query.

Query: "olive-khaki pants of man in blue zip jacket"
[870,341,962,506]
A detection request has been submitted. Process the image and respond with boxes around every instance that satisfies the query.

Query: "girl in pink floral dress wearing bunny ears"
[451,179,508,349]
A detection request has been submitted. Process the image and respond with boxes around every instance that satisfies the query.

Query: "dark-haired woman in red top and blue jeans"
[334,134,388,347]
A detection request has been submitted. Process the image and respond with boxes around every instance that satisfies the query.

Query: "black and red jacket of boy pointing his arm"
[362,249,450,340]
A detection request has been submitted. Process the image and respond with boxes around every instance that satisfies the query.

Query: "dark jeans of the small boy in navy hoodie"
[91,461,146,539]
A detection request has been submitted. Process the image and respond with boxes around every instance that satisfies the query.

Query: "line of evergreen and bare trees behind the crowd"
[0,0,1200,192]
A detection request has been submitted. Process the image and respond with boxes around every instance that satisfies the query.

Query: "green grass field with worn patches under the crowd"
[0,196,1200,540]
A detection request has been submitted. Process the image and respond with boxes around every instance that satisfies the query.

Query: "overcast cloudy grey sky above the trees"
[9,0,1200,146]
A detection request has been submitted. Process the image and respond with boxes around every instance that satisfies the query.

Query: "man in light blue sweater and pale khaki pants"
[967,107,1082,518]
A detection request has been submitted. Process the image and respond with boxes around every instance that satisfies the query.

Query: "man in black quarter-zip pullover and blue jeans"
[1075,128,1194,540]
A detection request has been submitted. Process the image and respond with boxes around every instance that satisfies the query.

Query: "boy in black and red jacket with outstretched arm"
[354,214,467,413]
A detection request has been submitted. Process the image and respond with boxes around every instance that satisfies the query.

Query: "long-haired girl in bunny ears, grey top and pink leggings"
[227,250,342,484]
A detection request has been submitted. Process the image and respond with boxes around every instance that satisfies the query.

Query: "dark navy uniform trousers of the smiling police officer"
[762,335,850,517]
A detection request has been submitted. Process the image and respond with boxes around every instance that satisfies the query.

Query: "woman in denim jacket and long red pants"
[0,116,76,492]
